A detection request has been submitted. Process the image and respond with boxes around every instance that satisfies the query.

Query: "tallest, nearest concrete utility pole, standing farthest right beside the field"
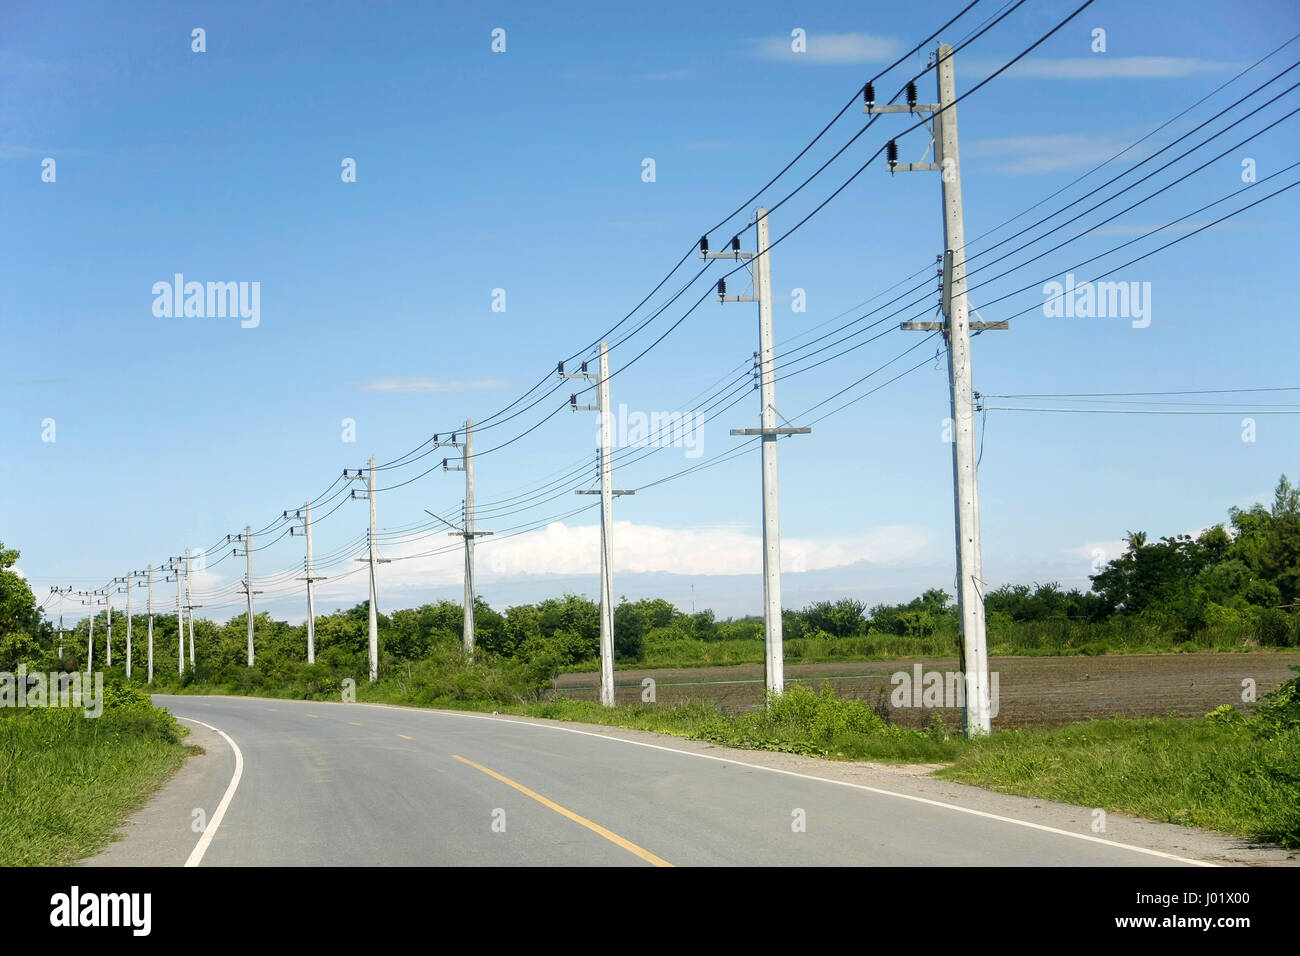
[863,43,1006,736]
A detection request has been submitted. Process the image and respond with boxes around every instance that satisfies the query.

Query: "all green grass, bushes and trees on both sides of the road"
[0,476,1300,862]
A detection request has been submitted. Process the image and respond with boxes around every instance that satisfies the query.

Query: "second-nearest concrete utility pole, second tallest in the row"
[699,208,813,695]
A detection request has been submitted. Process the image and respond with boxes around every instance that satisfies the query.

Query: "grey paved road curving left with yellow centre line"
[126,696,1211,866]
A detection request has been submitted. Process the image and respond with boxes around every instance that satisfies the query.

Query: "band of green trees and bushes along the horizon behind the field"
[22,476,1300,702]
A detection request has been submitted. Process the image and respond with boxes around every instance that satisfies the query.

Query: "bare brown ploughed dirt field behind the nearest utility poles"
[554,652,1300,730]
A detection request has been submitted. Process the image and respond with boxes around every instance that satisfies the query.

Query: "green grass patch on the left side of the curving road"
[0,691,186,866]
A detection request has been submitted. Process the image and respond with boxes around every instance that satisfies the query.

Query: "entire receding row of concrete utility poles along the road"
[40,44,1006,734]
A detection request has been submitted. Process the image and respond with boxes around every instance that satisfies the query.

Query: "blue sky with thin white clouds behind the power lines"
[0,0,1300,619]
